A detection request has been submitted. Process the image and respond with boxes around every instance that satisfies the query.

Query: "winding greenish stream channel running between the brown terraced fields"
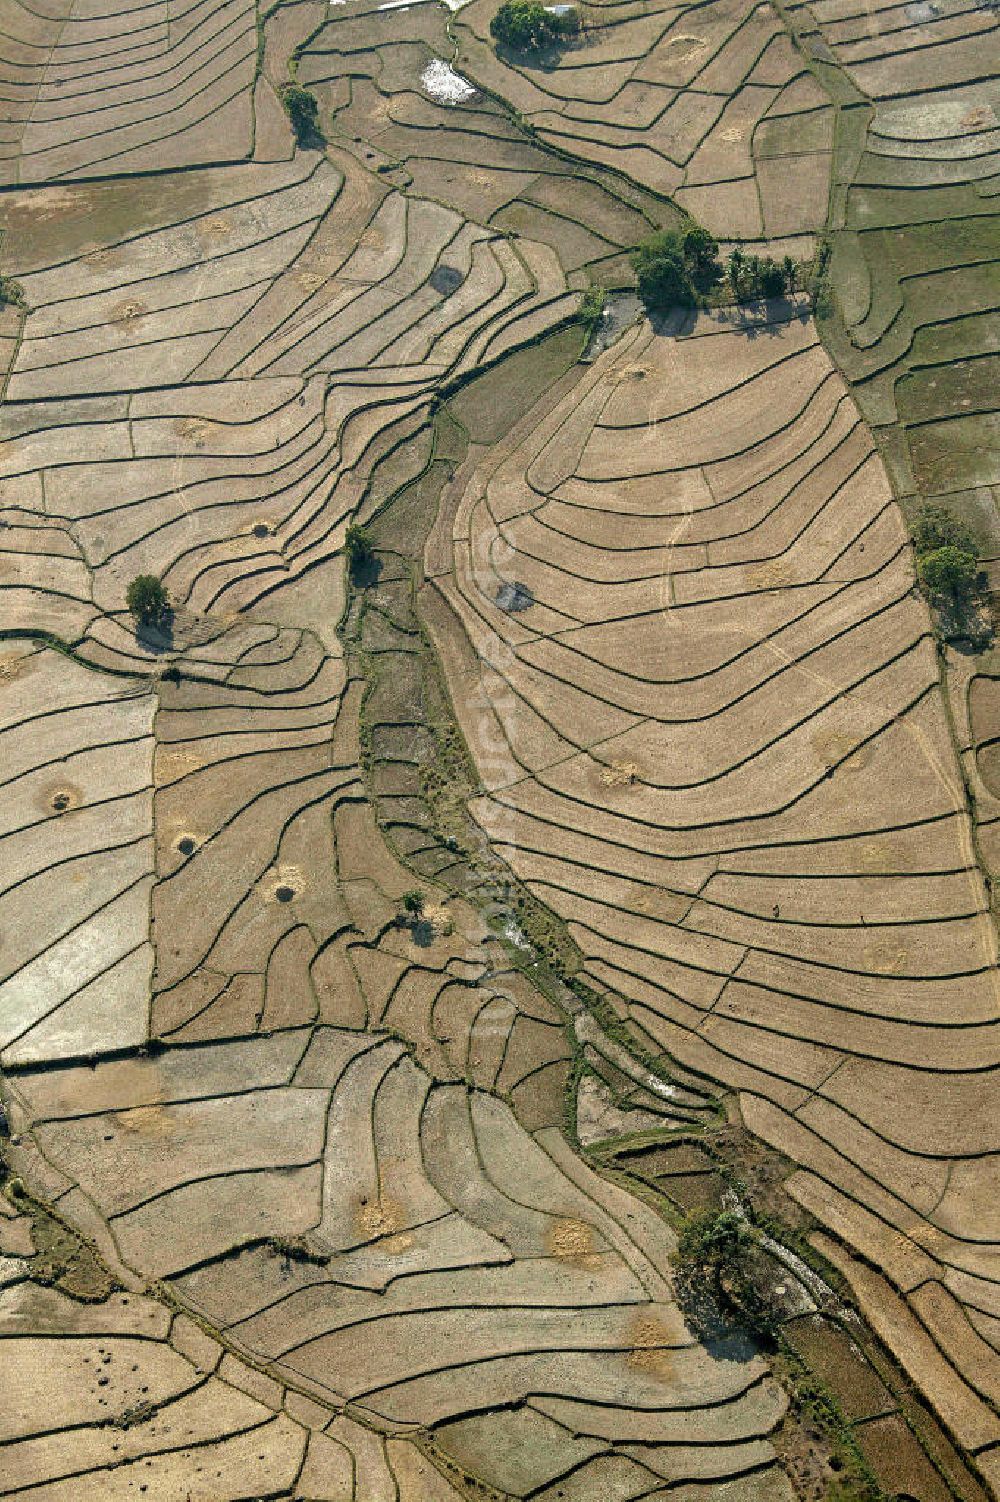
[341,320,985,1502]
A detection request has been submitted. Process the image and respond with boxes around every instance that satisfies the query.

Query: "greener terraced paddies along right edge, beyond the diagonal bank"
[782,0,1000,901]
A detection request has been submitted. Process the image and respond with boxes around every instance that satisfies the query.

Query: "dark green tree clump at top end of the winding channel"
[632,224,797,308]
